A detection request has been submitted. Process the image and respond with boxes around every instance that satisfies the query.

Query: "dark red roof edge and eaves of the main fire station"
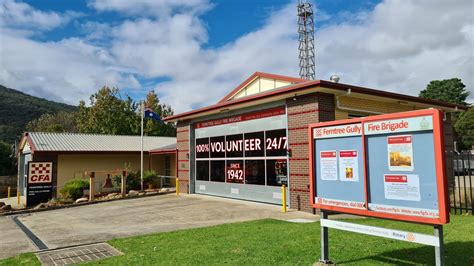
[163,72,467,122]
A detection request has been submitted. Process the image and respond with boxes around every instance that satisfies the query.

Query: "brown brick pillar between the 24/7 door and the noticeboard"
[286,93,335,212]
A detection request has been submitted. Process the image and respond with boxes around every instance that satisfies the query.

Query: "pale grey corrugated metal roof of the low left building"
[28,132,176,152]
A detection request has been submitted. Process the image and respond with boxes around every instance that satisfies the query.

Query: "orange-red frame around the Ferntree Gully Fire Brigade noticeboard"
[308,109,449,225]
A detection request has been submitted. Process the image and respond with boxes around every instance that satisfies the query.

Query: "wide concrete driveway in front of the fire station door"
[0,194,318,258]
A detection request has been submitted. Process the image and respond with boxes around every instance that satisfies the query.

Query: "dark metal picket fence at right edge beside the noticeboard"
[450,151,474,214]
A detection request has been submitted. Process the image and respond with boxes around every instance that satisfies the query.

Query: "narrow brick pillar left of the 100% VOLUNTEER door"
[176,121,191,193]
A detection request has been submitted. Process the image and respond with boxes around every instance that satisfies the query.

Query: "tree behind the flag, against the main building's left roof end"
[143,91,176,137]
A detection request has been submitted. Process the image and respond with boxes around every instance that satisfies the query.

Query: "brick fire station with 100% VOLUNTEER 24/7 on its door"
[165,72,464,211]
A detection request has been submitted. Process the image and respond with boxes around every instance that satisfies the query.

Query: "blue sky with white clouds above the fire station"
[0,0,474,112]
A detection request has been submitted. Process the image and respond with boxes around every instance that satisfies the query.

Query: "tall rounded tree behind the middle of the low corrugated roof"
[76,86,140,135]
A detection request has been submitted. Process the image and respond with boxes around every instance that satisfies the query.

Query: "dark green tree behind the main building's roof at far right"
[419,78,469,105]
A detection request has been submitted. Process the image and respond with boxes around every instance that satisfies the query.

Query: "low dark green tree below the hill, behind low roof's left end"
[26,111,77,132]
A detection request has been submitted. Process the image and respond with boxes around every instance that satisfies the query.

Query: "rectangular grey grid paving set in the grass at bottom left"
[36,243,122,266]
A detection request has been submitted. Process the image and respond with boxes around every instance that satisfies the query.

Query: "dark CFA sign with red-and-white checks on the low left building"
[26,162,53,207]
